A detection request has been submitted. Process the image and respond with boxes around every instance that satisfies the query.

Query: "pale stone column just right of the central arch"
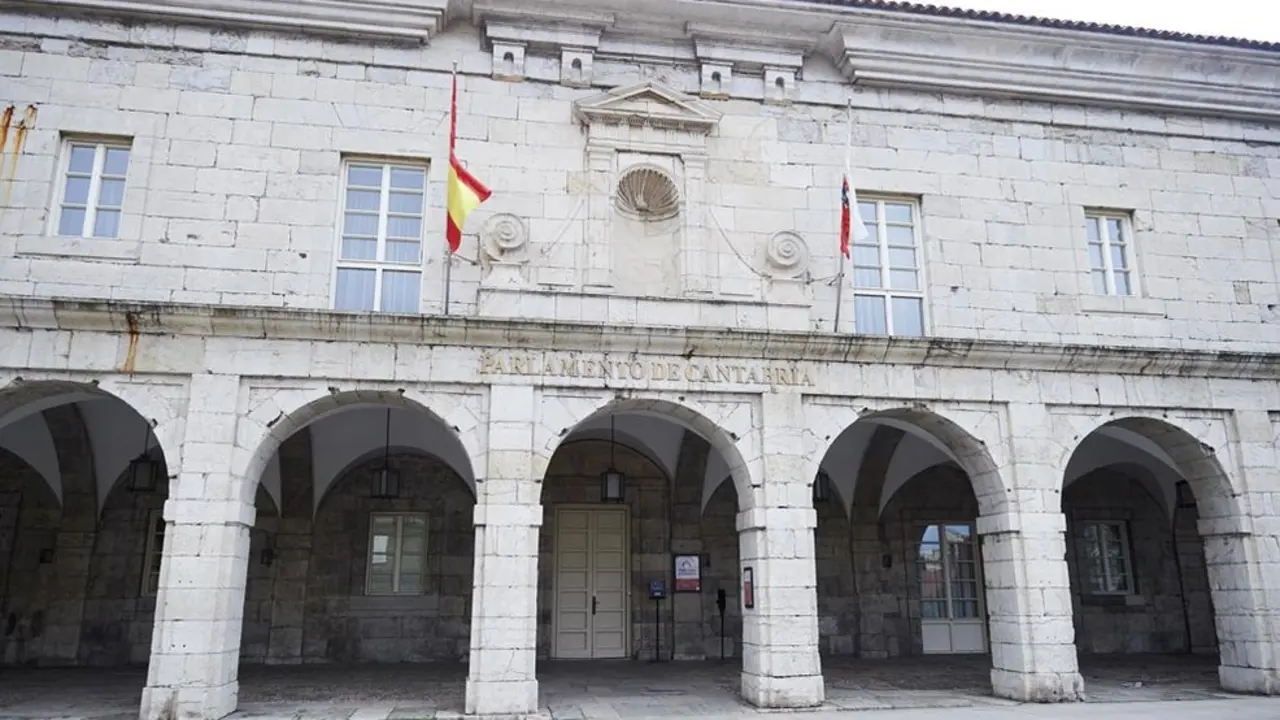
[737,393,824,707]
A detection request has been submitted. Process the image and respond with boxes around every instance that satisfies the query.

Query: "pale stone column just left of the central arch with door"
[466,386,543,715]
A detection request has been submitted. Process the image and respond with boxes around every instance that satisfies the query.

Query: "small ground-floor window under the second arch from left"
[365,512,426,594]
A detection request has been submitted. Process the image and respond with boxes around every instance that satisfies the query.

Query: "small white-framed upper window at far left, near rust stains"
[50,138,131,238]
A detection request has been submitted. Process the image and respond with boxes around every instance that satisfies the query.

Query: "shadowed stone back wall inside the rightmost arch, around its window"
[1062,469,1216,653]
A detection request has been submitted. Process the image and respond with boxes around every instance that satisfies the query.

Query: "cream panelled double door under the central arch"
[556,507,628,659]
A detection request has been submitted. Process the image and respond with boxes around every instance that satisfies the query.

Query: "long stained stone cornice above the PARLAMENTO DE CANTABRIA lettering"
[0,297,1280,380]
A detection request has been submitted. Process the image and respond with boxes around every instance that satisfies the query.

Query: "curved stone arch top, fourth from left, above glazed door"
[805,402,1010,515]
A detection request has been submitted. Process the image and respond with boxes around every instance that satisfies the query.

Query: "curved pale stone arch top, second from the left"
[232,384,488,505]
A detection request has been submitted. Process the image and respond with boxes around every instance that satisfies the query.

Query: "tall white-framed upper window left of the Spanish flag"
[333,160,426,314]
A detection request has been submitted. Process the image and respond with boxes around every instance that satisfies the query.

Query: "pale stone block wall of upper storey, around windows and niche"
[0,13,1280,351]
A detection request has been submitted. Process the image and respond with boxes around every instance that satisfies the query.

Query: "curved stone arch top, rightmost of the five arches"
[1055,414,1242,520]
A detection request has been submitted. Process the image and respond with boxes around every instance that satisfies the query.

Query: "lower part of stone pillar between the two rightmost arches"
[978,512,1084,702]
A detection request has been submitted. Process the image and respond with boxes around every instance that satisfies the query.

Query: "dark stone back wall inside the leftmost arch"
[0,405,168,666]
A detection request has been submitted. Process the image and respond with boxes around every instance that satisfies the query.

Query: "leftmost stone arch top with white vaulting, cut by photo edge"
[0,375,184,512]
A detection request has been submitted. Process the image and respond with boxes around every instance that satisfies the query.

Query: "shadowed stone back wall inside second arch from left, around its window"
[249,445,475,664]
